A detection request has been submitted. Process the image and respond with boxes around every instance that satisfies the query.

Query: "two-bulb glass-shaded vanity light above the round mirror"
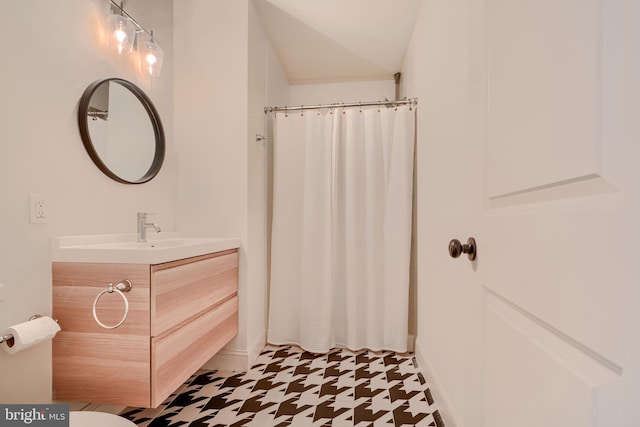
[108,0,164,77]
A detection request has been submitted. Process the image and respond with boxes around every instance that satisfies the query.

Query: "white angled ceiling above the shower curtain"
[254,0,422,84]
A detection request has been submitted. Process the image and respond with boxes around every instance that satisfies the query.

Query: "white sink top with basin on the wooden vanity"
[51,232,240,264]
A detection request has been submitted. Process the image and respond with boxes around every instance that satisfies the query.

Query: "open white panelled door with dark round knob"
[480,0,640,427]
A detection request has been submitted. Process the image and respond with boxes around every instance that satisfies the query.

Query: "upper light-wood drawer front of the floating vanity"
[151,250,238,336]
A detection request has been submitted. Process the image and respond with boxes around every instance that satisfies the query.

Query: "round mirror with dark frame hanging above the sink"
[78,78,165,184]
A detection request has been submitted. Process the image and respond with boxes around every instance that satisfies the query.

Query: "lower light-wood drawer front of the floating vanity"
[151,296,238,407]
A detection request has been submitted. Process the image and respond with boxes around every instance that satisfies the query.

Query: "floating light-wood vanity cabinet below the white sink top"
[52,249,238,407]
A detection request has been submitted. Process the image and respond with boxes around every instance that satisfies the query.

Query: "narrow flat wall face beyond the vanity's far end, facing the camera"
[174,0,250,364]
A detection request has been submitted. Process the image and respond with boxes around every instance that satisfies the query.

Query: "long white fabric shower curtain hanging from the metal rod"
[268,105,415,352]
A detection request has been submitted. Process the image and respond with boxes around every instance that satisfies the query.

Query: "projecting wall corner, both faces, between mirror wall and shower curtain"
[174,0,287,369]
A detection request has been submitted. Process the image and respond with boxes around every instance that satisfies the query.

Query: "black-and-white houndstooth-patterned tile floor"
[120,346,444,427]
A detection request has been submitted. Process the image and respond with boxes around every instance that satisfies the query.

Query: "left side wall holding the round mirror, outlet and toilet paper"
[0,0,177,403]
